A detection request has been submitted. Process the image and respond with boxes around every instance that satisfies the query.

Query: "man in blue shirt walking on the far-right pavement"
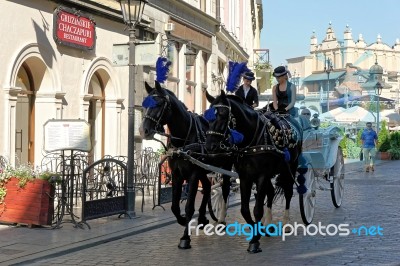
[361,122,378,172]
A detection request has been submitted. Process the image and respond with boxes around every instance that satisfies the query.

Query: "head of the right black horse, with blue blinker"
[204,91,236,151]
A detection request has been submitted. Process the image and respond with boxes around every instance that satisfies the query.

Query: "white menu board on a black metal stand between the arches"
[44,119,92,152]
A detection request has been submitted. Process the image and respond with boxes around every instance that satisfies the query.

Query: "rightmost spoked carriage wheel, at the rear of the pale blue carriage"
[330,147,344,208]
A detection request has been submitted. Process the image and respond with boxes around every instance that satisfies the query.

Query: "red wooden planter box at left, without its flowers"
[0,178,55,226]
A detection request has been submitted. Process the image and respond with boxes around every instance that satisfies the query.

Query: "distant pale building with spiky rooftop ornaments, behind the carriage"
[287,24,400,111]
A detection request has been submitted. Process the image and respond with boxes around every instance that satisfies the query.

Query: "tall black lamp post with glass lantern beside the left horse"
[119,0,147,217]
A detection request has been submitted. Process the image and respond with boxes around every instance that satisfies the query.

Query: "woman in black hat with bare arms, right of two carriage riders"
[272,66,297,117]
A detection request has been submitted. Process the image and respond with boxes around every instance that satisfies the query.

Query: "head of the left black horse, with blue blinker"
[140,81,171,139]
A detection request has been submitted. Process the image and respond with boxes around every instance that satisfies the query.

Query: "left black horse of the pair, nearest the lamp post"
[140,81,232,249]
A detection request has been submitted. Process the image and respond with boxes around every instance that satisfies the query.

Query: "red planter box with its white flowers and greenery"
[0,164,61,226]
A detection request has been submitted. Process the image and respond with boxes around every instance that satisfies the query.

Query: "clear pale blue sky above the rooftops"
[260,0,400,68]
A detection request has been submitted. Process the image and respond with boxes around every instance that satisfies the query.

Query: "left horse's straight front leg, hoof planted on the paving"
[178,174,199,249]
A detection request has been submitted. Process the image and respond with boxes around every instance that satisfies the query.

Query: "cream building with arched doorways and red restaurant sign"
[0,0,262,165]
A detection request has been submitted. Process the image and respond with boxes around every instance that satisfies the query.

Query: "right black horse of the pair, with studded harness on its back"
[206,91,304,253]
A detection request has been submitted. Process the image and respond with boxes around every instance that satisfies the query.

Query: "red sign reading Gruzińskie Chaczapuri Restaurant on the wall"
[53,7,96,50]
